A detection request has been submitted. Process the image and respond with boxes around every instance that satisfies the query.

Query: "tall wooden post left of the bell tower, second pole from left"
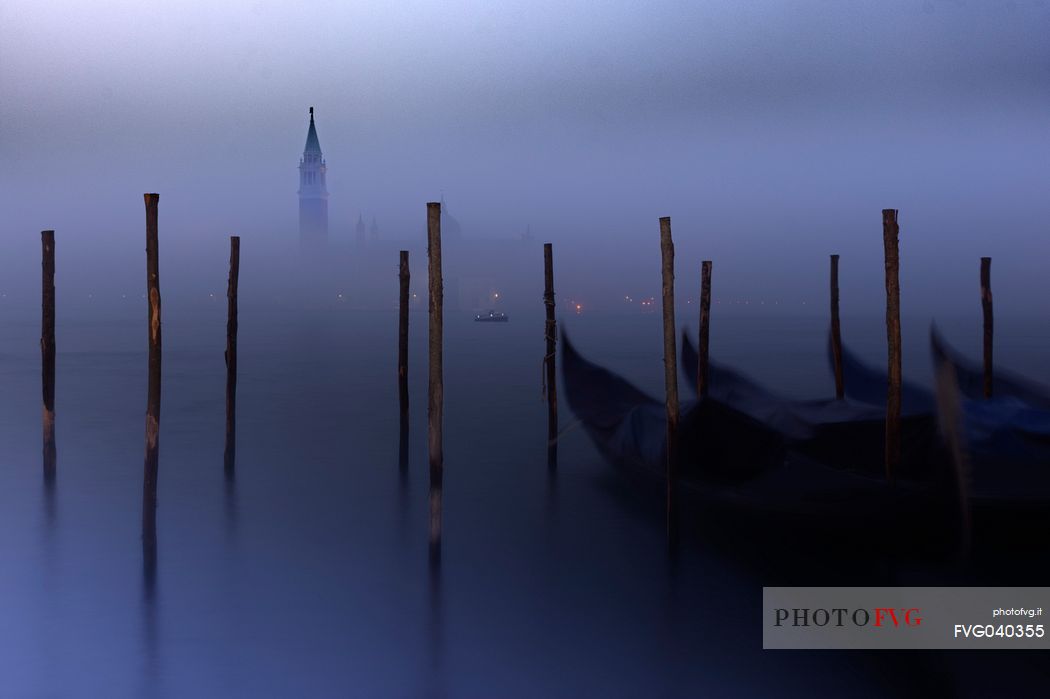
[142,194,161,565]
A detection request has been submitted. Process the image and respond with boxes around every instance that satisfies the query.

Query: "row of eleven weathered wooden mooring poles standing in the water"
[30,193,993,570]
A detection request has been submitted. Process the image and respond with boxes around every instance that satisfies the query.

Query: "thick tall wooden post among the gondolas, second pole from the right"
[882,209,901,483]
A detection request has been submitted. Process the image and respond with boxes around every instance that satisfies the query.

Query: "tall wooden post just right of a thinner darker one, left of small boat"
[426,202,444,562]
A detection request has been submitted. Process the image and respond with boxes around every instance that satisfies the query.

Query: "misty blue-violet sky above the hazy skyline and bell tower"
[0,0,1050,313]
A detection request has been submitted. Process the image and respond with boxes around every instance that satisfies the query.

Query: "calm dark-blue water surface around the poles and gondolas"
[0,304,1050,697]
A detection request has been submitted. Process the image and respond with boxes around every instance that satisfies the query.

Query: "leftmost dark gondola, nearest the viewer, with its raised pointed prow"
[561,331,937,532]
